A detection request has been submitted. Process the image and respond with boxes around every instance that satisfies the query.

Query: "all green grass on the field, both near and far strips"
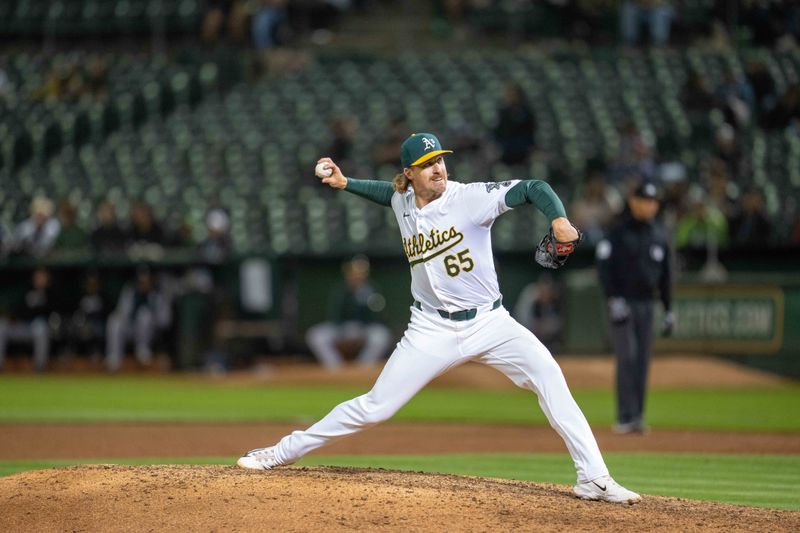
[0,376,800,510]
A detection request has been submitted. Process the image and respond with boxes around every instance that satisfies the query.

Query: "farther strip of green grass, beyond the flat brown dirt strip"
[0,377,800,432]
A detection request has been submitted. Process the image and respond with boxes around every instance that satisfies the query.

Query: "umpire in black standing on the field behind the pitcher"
[596,182,675,433]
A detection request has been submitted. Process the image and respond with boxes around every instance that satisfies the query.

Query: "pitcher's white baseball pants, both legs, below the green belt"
[275,307,608,482]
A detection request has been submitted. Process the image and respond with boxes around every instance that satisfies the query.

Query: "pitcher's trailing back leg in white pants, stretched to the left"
[275,338,460,464]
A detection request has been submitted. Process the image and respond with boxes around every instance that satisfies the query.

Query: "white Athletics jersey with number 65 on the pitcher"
[392,180,519,313]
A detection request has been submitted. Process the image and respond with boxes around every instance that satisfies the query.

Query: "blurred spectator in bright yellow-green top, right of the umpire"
[675,189,729,248]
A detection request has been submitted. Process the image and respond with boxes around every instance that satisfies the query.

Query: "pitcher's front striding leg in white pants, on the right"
[478,317,608,481]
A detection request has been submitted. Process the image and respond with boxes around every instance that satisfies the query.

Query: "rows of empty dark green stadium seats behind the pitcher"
[0,48,800,254]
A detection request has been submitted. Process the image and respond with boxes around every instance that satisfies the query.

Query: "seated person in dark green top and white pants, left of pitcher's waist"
[306,256,392,370]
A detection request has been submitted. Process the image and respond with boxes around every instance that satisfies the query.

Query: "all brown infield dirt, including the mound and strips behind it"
[0,359,800,532]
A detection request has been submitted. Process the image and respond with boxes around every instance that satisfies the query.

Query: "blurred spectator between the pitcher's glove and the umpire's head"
[570,165,622,245]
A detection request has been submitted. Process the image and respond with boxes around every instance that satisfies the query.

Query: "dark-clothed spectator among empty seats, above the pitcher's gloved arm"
[494,83,536,165]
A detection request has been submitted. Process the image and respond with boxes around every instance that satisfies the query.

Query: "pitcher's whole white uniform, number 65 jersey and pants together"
[275,181,608,482]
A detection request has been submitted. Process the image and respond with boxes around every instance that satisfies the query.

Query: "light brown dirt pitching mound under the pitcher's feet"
[0,465,800,532]
